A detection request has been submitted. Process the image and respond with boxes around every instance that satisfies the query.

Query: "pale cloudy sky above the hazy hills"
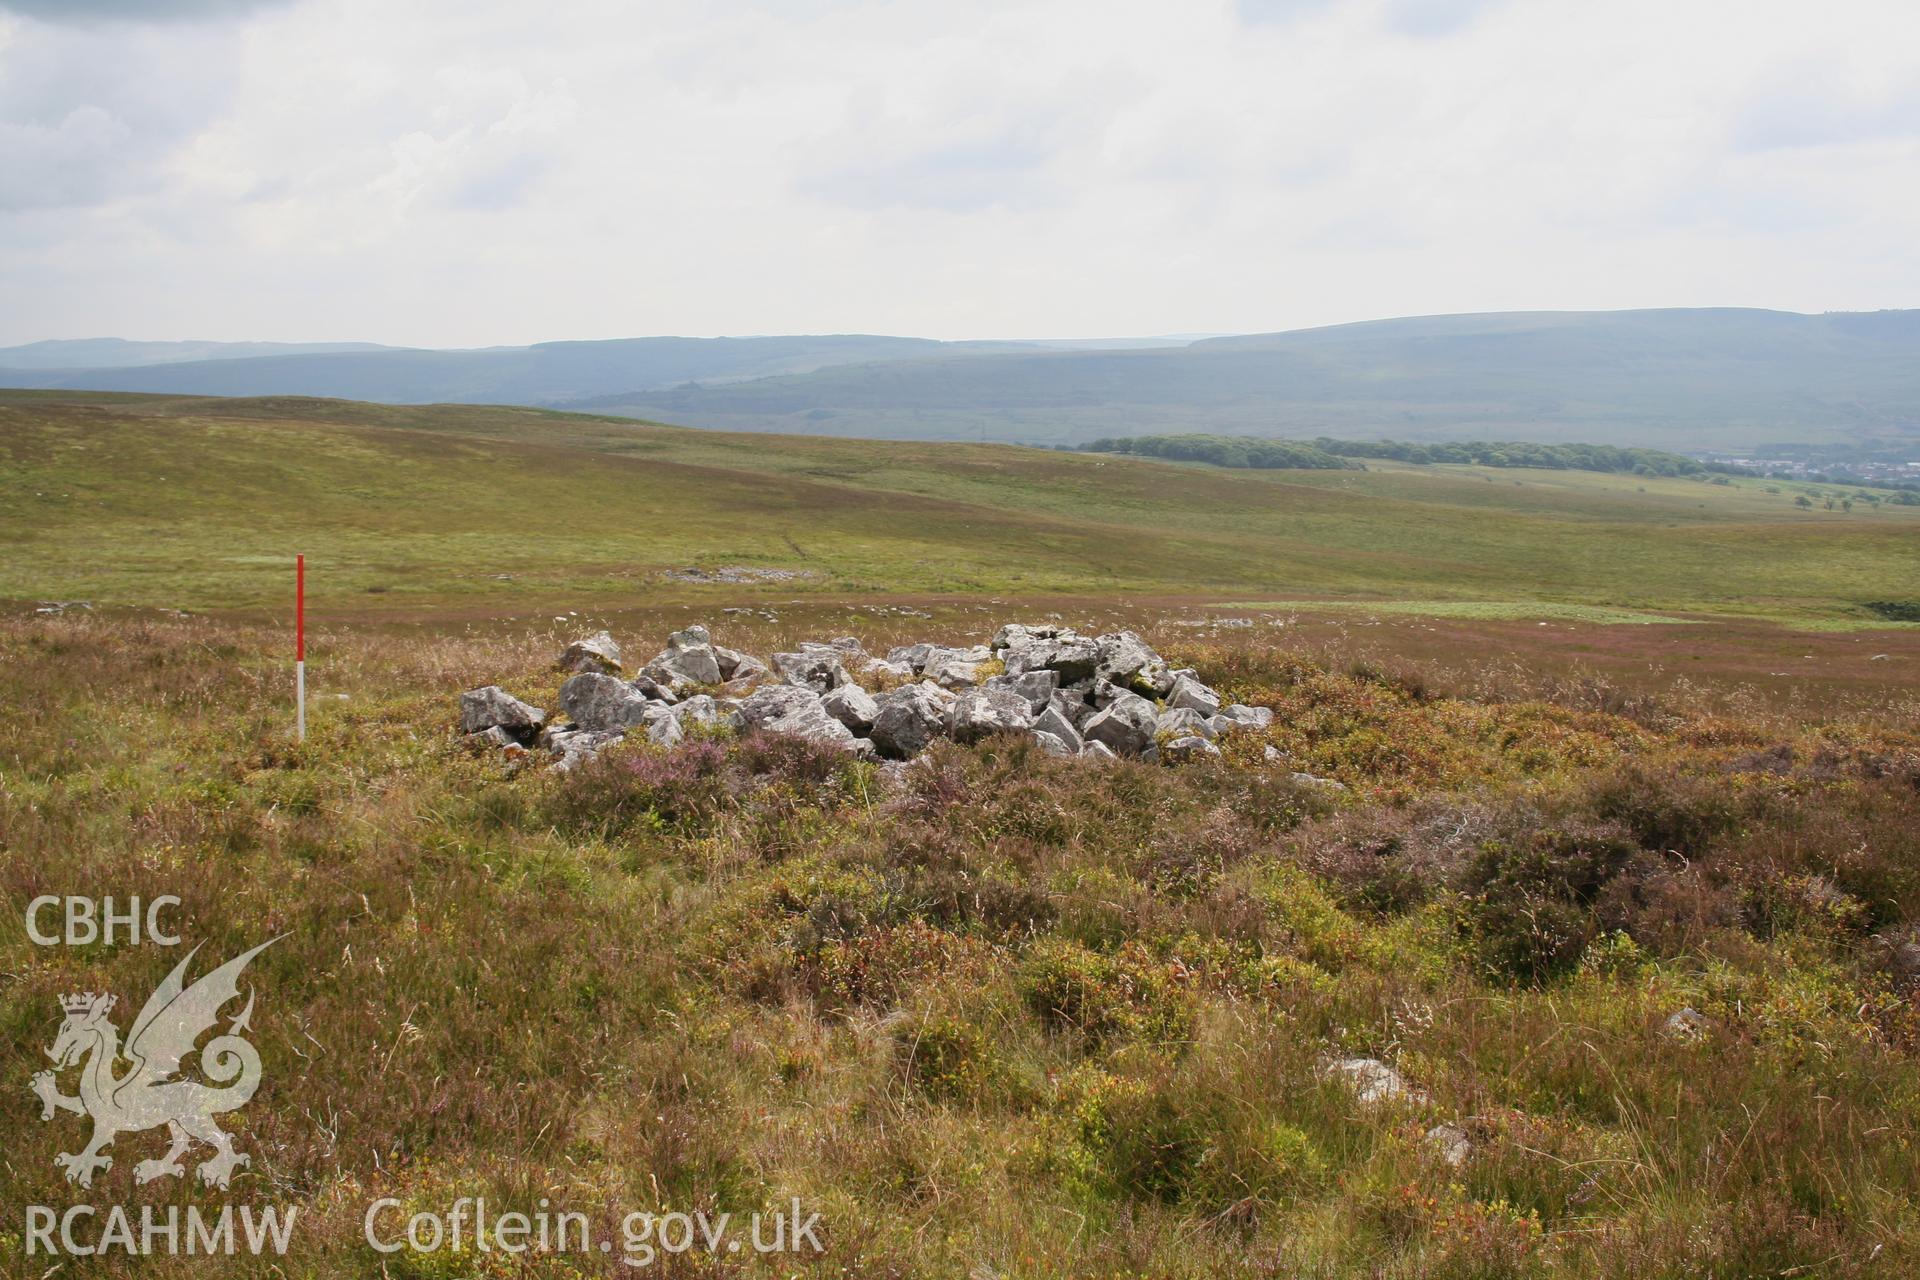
[0,0,1920,345]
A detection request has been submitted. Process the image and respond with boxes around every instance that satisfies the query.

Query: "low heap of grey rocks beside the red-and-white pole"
[461,624,1273,768]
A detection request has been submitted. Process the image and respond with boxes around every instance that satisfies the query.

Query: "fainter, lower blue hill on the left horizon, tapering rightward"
[0,334,1171,405]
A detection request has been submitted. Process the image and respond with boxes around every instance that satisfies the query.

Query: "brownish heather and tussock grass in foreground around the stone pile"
[0,608,1920,1280]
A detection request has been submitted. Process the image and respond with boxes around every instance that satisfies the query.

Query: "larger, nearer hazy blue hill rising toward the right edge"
[580,309,1920,449]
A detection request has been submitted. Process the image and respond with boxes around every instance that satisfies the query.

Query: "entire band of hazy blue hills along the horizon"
[11,309,1920,457]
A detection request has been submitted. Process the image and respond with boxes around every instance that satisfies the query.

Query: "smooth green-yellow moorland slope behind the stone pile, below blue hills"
[0,391,1920,624]
